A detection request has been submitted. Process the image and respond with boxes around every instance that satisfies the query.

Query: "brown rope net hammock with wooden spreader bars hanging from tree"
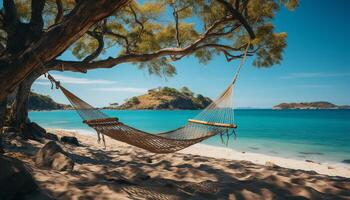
[48,42,250,153]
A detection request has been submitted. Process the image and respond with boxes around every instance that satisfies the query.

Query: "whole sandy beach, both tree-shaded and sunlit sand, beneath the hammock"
[5,129,350,199]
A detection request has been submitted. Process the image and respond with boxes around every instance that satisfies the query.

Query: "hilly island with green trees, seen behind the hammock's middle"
[103,87,212,110]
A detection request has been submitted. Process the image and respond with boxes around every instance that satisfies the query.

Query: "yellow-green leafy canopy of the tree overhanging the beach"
[0,0,298,76]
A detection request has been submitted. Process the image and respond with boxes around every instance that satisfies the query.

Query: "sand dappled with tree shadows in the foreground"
[2,138,350,199]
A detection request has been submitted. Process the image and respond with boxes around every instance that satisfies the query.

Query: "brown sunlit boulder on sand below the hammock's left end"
[34,141,74,171]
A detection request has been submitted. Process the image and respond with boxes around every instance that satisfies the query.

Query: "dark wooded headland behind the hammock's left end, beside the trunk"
[28,92,72,110]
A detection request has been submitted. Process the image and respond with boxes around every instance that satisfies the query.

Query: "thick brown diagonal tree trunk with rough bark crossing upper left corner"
[0,0,129,101]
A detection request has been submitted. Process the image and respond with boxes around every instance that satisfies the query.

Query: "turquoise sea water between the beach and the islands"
[30,109,350,162]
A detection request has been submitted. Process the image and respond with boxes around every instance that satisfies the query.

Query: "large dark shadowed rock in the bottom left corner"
[0,155,38,199]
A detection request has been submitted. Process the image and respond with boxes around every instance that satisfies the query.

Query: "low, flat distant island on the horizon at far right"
[273,101,350,110]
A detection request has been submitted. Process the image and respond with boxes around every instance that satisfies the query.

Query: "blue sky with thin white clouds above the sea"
[33,0,350,108]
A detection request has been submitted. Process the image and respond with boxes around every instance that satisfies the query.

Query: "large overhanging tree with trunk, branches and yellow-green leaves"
[0,0,298,134]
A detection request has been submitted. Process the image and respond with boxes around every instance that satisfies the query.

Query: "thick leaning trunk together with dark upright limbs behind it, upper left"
[0,0,129,100]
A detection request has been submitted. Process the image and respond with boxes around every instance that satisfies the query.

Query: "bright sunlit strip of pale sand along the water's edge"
[47,128,350,178]
